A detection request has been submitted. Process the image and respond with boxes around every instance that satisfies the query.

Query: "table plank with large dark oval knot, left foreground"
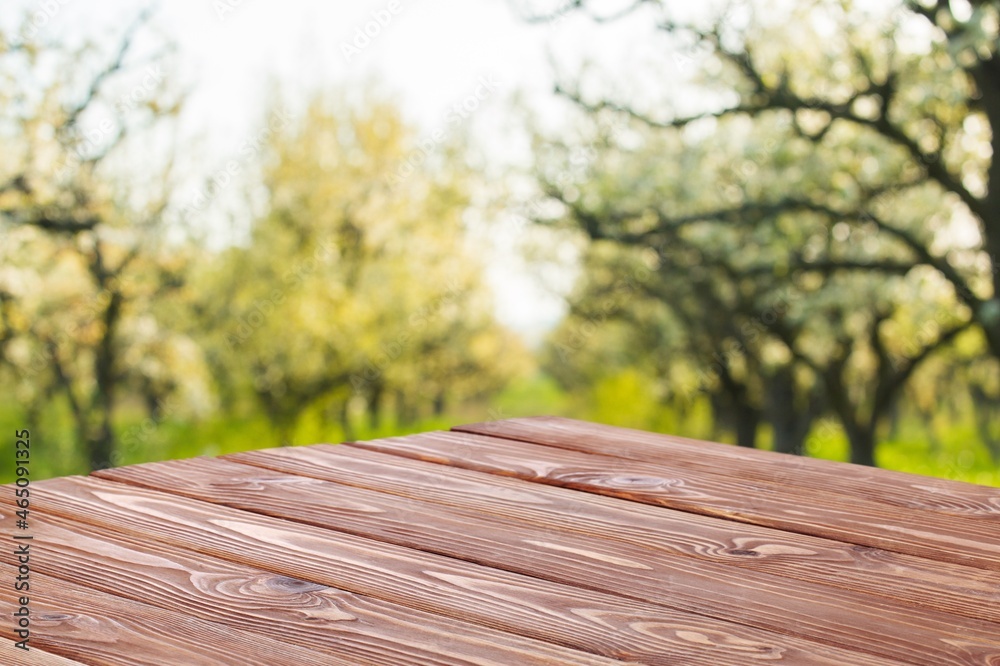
[0,505,636,666]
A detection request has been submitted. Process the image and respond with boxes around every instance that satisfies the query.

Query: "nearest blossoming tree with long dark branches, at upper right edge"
[530,0,1000,357]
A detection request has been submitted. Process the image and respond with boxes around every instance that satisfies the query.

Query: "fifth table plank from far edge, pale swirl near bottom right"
[15,477,912,666]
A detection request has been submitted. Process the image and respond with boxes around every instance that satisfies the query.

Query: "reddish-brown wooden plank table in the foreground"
[0,418,1000,666]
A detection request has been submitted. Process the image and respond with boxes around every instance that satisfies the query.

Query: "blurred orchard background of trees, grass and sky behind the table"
[0,0,1000,485]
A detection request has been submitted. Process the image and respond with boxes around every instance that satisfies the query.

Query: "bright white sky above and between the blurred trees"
[2,0,680,339]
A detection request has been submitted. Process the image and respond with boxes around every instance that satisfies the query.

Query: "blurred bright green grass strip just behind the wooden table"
[0,371,1000,486]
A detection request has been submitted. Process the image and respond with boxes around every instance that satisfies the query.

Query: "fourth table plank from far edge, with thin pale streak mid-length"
[92,458,1000,664]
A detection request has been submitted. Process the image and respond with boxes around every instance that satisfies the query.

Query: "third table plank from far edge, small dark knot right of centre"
[225,435,1000,623]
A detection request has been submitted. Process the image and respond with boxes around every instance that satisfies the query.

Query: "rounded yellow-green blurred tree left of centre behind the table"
[200,96,524,443]
